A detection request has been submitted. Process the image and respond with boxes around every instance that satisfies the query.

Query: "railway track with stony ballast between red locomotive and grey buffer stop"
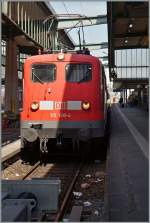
[2,148,105,222]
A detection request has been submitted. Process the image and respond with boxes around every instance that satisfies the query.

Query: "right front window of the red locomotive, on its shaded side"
[66,64,92,83]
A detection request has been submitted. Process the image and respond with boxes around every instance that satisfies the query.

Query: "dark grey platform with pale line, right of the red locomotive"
[106,104,149,222]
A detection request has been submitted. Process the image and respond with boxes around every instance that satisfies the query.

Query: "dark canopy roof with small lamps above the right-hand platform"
[107,1,149,89]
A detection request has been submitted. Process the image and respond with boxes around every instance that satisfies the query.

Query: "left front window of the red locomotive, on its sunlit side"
[32,64,56,83]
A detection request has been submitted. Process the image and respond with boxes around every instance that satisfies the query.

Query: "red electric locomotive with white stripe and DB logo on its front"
[21,49,108,161]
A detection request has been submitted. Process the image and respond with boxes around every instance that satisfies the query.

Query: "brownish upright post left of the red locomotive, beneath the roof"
[5,39,19,114]
